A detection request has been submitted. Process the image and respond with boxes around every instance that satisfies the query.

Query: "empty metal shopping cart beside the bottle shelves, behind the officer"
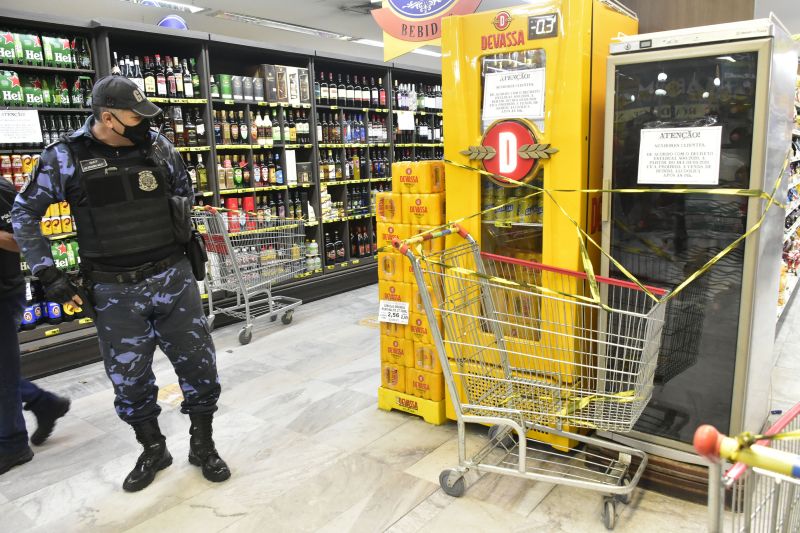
[193,210,305,344]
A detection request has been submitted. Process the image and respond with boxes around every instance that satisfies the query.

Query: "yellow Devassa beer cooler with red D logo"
[442,0,638,448]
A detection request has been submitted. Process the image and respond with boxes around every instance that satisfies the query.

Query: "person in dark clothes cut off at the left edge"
[0,178,69,474]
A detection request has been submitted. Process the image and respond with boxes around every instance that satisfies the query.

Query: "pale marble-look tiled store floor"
[0,287,800,533]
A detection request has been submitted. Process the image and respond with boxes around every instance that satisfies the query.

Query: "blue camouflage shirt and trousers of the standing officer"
[12,117,220,424]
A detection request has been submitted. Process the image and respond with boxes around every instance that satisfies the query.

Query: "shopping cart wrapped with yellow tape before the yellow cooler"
[394,226,666,529]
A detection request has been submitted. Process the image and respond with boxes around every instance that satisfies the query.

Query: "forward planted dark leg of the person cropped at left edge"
[0,297,33,474]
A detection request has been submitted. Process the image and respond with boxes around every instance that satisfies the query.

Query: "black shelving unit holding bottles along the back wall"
[0,10,443,377]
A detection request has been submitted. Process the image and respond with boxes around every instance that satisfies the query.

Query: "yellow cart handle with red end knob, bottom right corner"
[694,424,800,479]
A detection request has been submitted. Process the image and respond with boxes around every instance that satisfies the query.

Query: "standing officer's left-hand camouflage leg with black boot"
[92,283,172,492]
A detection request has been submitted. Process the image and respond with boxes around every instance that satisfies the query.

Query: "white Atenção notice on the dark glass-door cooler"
[637,126,722,185]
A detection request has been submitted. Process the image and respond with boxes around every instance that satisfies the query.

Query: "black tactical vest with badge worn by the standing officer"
[67,139,176,262]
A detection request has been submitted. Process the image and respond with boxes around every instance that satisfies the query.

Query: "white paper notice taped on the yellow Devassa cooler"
[482,68,544,124]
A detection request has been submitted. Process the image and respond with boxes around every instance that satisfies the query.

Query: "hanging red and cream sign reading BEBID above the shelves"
[372,0,481,61]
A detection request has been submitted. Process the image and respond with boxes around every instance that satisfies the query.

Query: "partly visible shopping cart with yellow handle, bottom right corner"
[694,404,800,533]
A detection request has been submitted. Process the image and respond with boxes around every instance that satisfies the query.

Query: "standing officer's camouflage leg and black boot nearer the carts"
[152,260,231,481]
